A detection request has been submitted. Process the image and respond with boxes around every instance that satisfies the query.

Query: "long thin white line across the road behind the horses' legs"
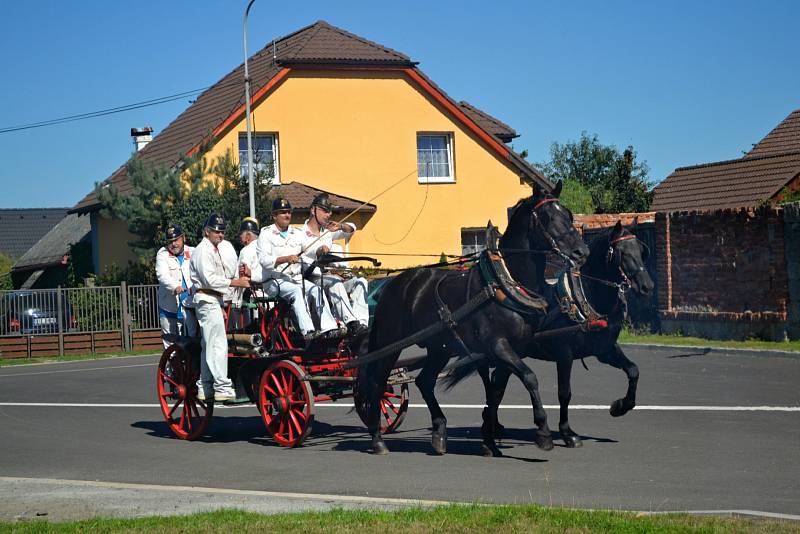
[0,402,800,412]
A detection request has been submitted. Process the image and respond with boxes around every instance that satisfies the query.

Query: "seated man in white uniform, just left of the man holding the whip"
[256,198,342,342]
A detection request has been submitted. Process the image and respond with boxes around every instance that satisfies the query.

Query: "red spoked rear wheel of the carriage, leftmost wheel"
[156,345,214,440]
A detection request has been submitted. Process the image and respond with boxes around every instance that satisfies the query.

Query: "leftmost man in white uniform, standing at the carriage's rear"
[156,224,197,349]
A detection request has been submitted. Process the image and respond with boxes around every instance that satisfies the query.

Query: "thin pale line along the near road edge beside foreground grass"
[0,476,800,521]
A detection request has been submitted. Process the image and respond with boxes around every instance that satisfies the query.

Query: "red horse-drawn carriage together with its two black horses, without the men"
[158,185,653,455]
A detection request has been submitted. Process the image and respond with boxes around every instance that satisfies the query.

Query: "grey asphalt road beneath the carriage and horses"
[0,348,800,519]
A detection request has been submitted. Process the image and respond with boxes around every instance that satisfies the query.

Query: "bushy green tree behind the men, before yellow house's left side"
[96,144,272,284]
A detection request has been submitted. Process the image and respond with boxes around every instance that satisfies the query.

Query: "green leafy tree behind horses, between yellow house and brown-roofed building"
[537,131,653,213]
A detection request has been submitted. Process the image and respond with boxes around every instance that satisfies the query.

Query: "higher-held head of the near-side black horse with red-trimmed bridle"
[523,181,589,267]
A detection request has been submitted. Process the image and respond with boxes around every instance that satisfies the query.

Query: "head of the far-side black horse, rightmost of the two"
[606,221,654,295]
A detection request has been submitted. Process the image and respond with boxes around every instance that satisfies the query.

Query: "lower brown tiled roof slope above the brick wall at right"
[650,151,800,211]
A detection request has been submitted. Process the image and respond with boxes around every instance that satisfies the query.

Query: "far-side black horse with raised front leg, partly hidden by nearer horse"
[445,222,653,455]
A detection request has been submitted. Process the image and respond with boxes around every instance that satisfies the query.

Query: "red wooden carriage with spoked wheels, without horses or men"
[157,256,409,447]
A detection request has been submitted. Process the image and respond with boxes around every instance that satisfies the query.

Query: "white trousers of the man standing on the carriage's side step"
[195,302,235,397]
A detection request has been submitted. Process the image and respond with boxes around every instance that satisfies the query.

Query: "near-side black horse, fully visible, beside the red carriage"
[354,183,589,454]
